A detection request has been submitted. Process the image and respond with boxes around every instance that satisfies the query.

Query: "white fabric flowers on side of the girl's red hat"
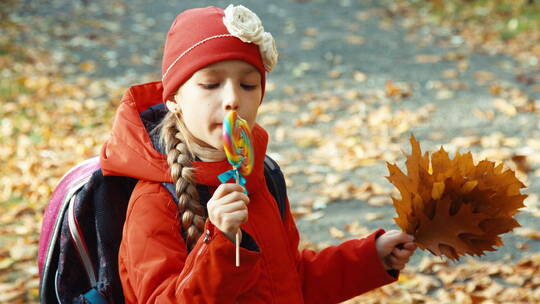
[223,4,278,72]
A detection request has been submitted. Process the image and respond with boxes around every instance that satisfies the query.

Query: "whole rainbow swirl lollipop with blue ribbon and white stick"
[219,111,254,267]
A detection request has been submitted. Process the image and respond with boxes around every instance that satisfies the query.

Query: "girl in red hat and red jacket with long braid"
[101,5,416,303]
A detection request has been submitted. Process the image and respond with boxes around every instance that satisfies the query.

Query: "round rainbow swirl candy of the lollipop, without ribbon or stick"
[223,111,253,176]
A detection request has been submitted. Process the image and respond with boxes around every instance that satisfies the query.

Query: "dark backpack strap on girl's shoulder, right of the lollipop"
[264,155,287,220]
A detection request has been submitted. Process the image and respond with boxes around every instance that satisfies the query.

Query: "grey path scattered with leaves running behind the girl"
[14,0,540,262]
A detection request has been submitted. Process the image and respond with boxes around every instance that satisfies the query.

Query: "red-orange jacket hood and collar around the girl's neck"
[100,81,268,190]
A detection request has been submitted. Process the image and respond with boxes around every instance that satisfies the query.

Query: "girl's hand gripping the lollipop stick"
[207,183,249,243]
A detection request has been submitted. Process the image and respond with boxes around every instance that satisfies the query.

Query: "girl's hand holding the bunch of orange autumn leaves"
[375,230,416,270]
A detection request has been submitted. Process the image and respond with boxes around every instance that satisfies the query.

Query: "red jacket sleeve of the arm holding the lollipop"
[119,187,260,303]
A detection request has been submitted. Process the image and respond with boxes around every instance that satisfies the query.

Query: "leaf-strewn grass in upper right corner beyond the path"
[388,0,540,66]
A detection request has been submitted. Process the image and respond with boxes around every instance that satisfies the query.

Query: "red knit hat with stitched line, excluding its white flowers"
[158,7,277,101]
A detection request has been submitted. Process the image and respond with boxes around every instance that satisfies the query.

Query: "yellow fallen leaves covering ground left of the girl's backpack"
[0,1,139,303]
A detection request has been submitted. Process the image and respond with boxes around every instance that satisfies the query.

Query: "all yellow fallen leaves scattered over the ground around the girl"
[0,0,540,303]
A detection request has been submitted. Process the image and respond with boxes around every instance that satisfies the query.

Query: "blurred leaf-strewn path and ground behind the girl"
[0,0,540,303]
